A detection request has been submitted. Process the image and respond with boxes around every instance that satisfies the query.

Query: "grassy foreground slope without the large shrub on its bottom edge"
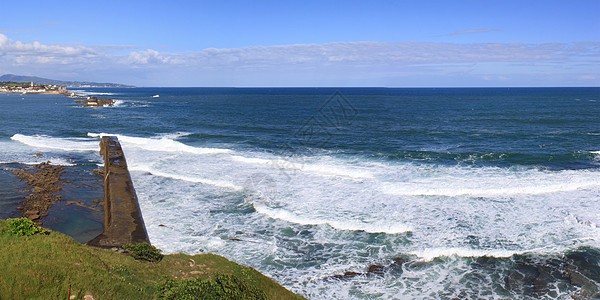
[0,220,302,299]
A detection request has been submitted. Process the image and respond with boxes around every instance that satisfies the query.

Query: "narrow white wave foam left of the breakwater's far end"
[10,133,99,151]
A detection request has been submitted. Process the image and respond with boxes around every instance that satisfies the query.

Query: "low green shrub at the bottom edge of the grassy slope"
[158,274,268,300]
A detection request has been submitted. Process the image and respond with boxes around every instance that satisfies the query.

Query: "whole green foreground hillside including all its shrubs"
[0,220,303,299]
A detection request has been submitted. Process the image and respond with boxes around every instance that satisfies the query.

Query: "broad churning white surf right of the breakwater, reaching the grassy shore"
[38,132,600,298]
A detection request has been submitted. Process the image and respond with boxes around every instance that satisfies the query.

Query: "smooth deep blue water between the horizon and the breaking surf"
[0,88,600,169]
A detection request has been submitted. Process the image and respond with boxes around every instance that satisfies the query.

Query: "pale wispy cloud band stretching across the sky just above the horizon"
[0,33,600,86]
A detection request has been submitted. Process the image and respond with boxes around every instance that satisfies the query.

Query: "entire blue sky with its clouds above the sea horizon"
[0,0,600,87]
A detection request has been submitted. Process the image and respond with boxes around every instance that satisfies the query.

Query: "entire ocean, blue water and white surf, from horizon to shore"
[0,88,600,299]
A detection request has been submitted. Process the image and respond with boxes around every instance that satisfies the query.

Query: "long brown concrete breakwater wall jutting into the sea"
[87,136,149,247]
